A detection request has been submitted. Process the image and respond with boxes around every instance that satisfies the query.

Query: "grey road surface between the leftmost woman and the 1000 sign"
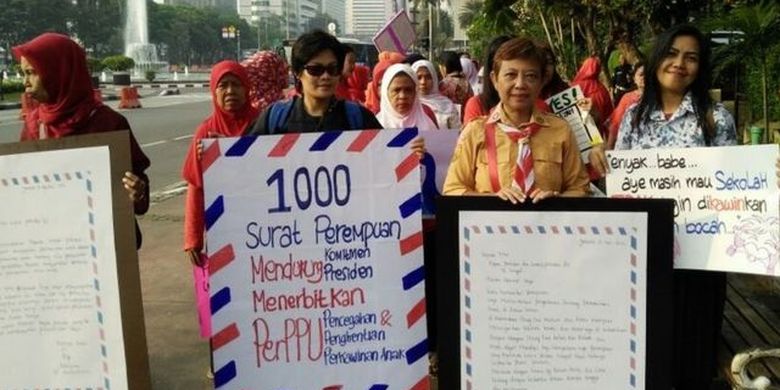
[0,89,213,390]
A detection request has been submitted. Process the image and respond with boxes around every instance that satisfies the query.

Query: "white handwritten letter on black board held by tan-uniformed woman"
[458,211,648,390]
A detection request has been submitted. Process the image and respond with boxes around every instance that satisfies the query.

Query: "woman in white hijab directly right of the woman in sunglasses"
[376,64,438,130]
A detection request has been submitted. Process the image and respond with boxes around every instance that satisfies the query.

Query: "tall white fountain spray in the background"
[125,0,168,76]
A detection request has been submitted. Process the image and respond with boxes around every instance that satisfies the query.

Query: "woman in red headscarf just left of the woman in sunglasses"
[182,61,258,272]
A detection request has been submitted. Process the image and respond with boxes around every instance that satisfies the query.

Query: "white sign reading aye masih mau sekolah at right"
[607,145,780,276]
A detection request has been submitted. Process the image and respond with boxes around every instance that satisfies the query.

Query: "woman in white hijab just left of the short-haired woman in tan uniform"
[412,60,460,130]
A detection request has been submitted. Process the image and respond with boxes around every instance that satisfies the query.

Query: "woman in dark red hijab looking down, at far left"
[13,33,149,248]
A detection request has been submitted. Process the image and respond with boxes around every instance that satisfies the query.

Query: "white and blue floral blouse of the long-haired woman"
[615,92,737,150]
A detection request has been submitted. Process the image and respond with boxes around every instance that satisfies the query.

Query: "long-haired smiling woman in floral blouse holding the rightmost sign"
[602,25,737,389]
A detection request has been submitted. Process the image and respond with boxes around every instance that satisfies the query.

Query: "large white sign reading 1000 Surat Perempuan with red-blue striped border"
[202,129,428,390]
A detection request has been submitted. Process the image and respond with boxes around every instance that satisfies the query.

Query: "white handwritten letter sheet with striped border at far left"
[0,146,128,389]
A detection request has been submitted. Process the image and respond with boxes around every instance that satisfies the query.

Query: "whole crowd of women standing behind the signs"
[14,25,780,389]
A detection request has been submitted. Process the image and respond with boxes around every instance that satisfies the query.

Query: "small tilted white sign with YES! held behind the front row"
[545,86,604,164]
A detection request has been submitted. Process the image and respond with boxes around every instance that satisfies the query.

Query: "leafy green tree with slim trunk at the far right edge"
[702,1,780,142]
